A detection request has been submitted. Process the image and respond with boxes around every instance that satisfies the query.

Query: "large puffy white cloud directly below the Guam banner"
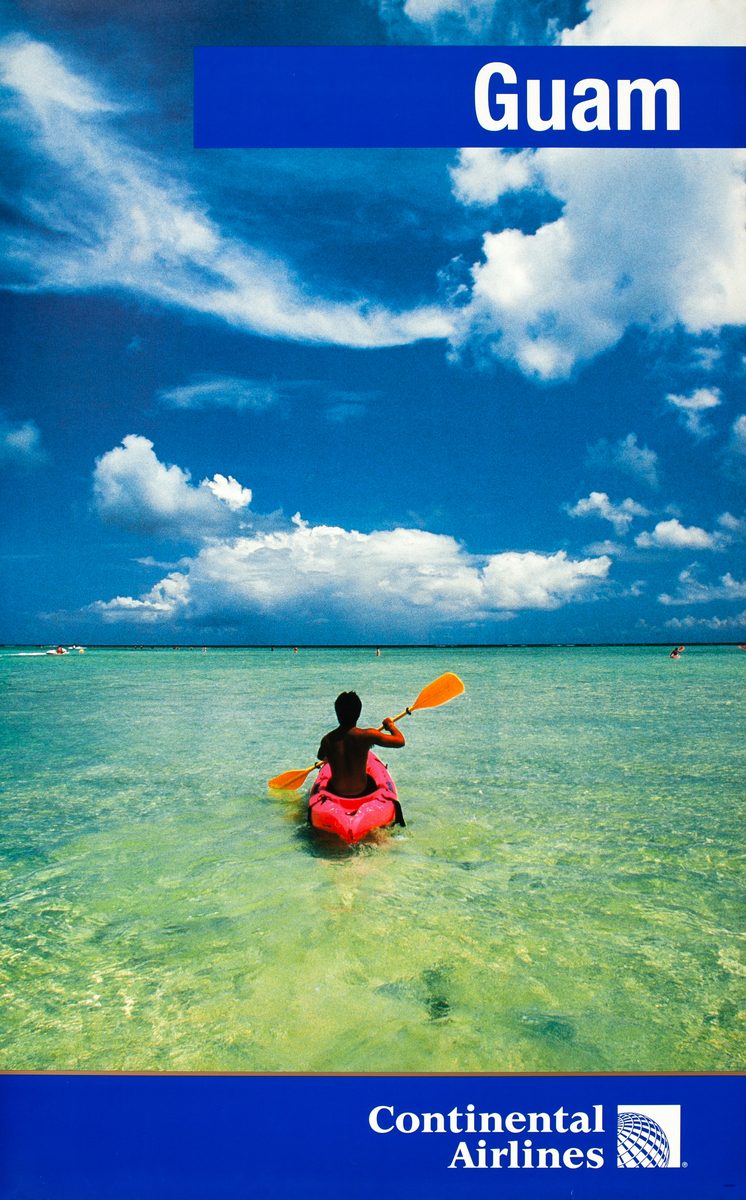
[451,148,746,379]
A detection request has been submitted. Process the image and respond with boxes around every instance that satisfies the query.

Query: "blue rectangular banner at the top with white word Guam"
[194,46,746,148]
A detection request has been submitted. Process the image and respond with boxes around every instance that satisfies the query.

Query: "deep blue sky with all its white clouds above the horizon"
[0,0,746,643]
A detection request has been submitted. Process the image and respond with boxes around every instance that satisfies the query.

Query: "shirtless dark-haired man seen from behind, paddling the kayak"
[317,691,404,799]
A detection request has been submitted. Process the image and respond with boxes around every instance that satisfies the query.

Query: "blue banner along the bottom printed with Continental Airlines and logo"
[0,1074,746,1200]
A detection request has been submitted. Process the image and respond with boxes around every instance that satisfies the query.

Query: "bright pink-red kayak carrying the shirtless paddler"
[308,750,405,844]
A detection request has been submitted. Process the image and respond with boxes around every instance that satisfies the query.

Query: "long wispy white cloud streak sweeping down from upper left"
[0,35,451,350]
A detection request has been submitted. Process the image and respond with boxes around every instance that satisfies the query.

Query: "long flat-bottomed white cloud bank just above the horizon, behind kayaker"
[87,525,610,630]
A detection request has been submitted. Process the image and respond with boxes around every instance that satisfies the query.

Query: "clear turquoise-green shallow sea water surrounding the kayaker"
[0,647,746,1072]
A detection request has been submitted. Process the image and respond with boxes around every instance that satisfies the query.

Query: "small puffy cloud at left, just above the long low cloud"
[94,433,251,539]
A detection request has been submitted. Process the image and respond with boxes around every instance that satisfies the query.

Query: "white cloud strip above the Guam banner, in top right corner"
[559,0,746,46]
